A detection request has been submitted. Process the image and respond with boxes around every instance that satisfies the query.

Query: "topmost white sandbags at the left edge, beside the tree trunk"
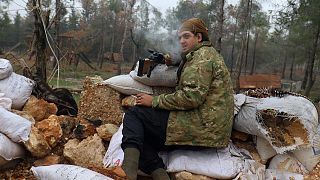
[0,58,35,110]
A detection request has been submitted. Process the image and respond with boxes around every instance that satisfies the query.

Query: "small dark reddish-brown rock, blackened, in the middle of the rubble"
[73,118,97,139]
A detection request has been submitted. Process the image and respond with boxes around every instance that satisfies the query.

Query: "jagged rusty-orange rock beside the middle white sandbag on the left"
[35,115,62,148]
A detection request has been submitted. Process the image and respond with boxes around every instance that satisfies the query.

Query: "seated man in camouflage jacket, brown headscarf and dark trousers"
[121,18,234,180]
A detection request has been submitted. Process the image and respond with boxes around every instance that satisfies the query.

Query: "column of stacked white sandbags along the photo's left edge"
[0,58,34,169]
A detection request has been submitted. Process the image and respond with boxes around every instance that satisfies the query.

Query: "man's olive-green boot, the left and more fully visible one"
[122,148,140,180]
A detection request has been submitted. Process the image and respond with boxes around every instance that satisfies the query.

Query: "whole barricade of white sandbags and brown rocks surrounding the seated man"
[0,54,320,179]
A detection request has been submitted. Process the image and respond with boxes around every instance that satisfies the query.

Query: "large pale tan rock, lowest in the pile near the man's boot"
[63,134,106,167]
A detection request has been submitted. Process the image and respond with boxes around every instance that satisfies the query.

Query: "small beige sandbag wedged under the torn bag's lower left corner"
[256,136,277,164]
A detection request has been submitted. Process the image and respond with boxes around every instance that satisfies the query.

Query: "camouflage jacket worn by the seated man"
[152,42,234,148]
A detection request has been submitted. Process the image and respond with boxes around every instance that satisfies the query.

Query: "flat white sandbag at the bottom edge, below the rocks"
[31,164,112,180]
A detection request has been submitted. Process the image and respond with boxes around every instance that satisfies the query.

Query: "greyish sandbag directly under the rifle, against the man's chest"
[130,62,178,87]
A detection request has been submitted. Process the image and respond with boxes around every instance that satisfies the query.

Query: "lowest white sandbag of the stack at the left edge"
[0,133,25,166]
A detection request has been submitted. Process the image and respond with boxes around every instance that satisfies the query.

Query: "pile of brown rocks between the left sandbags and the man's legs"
[0,75,123,179]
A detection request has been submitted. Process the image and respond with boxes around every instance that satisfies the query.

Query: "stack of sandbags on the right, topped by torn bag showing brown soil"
[233,95,320,179]
